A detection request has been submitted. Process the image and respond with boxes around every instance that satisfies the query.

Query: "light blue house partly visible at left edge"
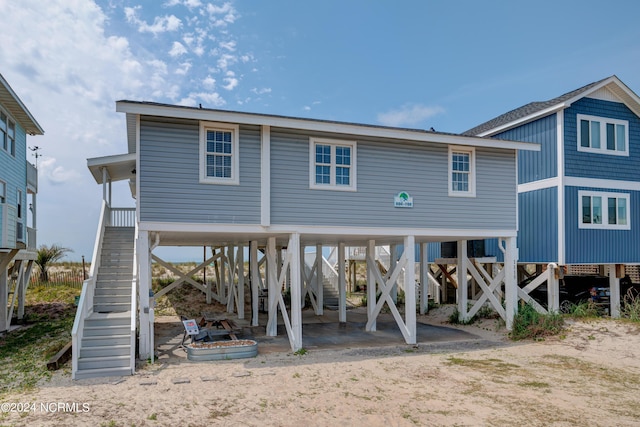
[0,74,44,332]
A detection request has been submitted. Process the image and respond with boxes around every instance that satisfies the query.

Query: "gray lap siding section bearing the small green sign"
[271,129,516,229]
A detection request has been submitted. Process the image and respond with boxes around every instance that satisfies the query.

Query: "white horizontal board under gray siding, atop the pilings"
[139,221,517,241]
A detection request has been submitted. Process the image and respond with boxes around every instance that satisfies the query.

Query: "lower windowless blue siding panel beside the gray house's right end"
[518,187,558,263]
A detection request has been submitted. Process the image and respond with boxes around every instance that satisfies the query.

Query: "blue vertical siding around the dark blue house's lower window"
[565,187,640,264]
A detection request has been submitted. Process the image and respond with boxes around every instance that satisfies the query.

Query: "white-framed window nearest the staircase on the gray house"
[200,122,240,185]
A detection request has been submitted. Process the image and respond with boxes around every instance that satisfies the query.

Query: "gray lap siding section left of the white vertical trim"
[138,117,260,224]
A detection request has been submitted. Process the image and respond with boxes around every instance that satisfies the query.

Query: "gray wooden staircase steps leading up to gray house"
[75,227,135,379]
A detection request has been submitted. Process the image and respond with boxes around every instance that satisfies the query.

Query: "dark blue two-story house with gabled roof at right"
[464,76,640,316]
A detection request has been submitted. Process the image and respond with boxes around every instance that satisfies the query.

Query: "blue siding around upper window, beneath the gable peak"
[564,98,640,181]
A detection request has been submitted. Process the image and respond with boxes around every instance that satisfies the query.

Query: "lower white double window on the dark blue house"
[578,191,631,230]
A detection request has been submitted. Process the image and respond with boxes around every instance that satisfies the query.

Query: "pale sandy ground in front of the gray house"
[0,313,640,426]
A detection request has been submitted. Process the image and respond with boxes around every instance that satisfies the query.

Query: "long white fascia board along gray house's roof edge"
[116,101,540,151]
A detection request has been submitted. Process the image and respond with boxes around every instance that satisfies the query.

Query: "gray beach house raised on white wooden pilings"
[73,101,539,377]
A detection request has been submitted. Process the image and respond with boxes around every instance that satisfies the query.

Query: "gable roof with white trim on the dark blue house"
[462,75,640,136]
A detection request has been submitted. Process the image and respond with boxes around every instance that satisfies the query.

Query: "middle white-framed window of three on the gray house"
[309,138,356,191]
